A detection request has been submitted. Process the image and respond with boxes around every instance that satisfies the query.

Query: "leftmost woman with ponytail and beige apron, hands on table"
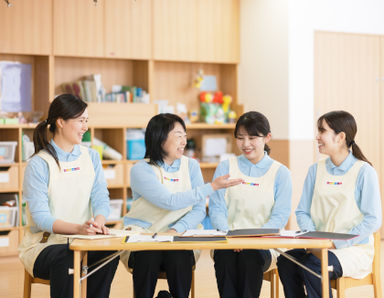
[19,94,118,298]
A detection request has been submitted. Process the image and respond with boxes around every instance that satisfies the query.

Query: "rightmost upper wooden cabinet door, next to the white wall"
[197,0,240,63]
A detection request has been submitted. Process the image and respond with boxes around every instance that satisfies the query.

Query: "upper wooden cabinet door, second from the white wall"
[152,0,197,61]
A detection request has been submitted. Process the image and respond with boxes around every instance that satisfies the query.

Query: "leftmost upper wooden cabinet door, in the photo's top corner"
[0,0,52,55]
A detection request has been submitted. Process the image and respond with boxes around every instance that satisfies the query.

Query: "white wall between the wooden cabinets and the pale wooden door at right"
[238,0,384,140]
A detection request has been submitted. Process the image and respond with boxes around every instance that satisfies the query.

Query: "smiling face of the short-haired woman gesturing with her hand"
[162,122,187,165]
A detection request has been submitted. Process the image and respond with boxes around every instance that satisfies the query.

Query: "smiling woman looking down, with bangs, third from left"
[209,112,292,297]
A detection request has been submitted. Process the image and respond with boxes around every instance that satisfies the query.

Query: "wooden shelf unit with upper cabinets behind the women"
[0,0,243,256]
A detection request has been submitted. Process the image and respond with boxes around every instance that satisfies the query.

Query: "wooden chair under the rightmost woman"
[331,231,383,298]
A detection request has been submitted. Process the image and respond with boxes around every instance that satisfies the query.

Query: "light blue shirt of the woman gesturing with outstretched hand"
[124,158,213,233]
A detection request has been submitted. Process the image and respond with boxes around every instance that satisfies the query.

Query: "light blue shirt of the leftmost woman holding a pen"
[23,140,109,233]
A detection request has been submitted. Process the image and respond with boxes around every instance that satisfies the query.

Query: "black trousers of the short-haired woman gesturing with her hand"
[128,250,195,298]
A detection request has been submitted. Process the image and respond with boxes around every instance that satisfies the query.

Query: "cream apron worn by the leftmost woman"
[19,146,95,276]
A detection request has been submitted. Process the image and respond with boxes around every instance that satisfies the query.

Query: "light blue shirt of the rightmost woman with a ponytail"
[296,152,381,248]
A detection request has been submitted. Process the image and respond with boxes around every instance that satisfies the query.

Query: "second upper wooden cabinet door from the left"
[53,0,104,57]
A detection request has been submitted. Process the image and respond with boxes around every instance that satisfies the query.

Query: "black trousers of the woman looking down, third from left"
[213,249,271,298]
